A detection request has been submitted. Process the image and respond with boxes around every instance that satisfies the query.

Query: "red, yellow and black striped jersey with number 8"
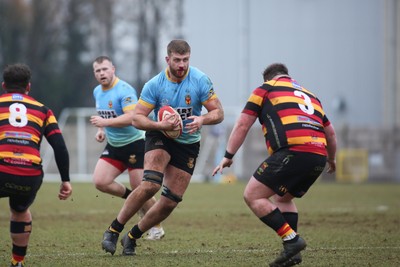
[0,93,65,179]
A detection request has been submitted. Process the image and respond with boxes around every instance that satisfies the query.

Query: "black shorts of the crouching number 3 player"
[253,149,326,197]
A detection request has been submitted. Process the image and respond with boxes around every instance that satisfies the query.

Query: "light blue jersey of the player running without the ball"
[93,78,145,147]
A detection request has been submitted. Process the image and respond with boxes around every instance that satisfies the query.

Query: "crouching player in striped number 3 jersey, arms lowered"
[213,63,336,267]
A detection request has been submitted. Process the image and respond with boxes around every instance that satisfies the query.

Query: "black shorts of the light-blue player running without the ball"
[100,139,144,172]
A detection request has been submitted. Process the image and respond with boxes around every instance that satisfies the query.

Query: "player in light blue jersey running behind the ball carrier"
[90,56,165,245]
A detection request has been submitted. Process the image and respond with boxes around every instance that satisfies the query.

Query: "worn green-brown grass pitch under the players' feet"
[0,182,400,267]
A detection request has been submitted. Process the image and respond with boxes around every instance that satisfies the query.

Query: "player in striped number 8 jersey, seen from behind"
[0,64,72,266]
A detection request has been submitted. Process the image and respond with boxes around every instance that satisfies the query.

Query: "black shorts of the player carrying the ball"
[146,131,200,175]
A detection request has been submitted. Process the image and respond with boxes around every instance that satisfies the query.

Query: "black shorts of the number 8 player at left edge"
[0,172,43,212]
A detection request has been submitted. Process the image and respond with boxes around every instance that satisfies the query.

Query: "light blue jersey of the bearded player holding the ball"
[139,66,217,144]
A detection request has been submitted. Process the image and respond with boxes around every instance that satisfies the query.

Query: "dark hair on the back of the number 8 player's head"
[3,63,32,93]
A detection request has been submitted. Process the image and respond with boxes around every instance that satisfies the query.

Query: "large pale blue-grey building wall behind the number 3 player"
[184,0,384,125]
